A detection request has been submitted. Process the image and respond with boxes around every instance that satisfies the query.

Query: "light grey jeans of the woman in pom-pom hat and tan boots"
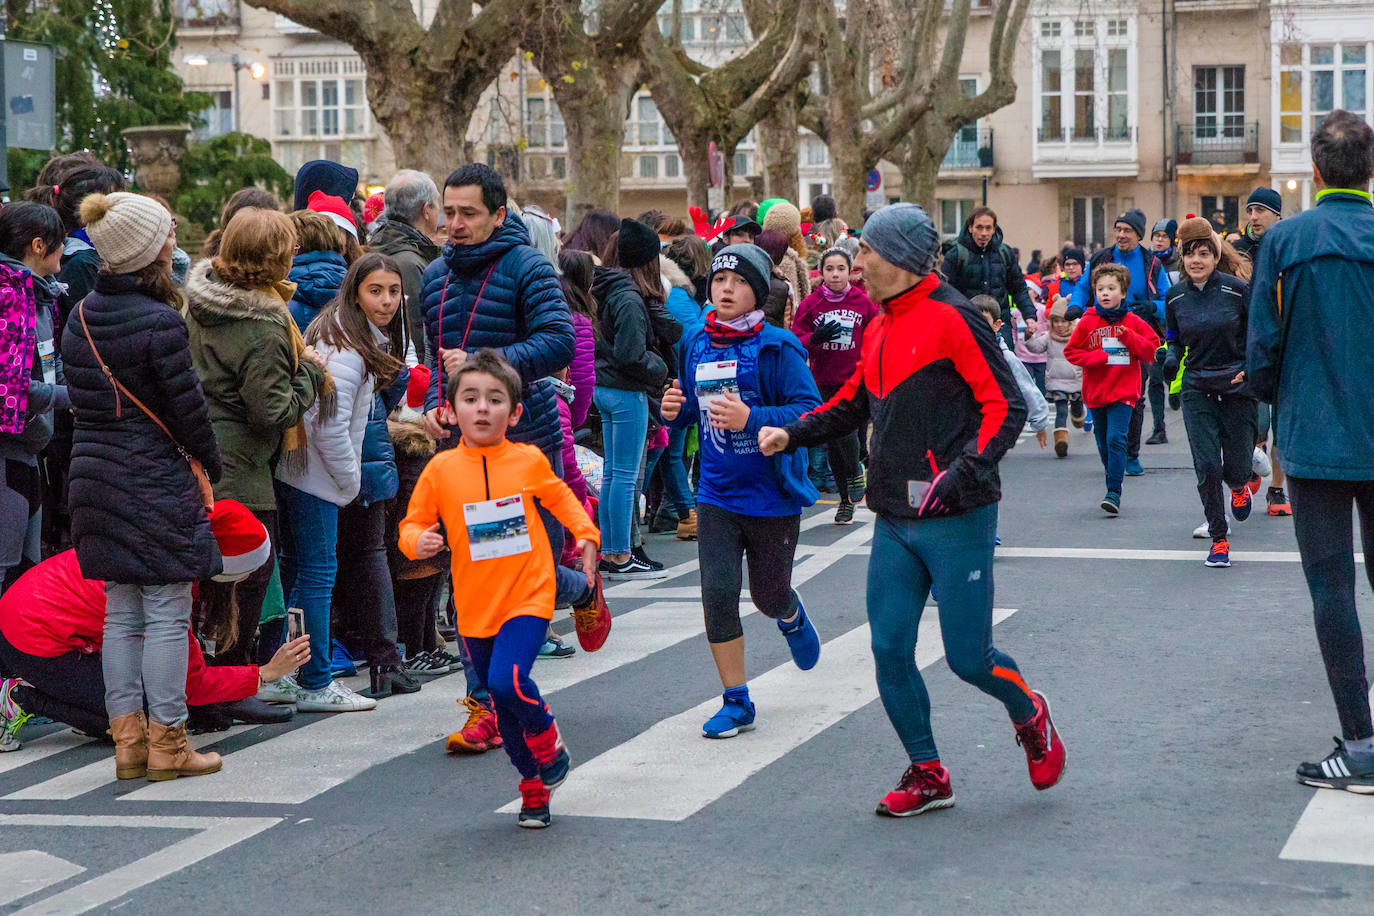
[100,582,191,725]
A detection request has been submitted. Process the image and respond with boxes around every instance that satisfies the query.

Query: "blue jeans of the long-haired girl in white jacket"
[276,481,339,691]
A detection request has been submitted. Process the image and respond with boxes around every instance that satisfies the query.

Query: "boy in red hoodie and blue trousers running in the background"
[1063,264,1160,515]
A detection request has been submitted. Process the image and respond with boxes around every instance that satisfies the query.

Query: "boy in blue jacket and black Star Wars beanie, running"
[662,244,820,737]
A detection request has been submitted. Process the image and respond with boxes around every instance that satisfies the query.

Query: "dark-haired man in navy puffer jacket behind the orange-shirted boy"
[420,163,574,458]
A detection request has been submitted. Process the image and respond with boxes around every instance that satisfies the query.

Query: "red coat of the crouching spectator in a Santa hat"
[0,551,258,706]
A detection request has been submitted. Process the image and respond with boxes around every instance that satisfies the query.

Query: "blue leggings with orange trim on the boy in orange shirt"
[459,617,554,779]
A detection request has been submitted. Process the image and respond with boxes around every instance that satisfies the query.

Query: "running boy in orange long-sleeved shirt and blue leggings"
[400,350,610,828]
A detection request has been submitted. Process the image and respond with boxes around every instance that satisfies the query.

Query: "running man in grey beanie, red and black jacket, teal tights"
[758,203,1063,817]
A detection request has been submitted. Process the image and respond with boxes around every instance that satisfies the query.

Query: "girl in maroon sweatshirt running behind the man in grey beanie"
[791,249,878,525]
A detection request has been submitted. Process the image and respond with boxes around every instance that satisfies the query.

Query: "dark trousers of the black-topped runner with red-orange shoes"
[1180,390,1254,540]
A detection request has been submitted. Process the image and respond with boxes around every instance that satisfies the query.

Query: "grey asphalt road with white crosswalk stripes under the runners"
[0,413,1374,915]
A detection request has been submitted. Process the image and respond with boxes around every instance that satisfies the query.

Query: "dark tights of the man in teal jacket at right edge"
[1287,477,1374,742]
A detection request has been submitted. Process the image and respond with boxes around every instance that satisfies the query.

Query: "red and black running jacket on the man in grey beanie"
[787,275,1026,519]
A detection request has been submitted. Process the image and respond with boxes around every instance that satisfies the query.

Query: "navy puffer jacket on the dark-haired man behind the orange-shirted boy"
[420,213,576,461]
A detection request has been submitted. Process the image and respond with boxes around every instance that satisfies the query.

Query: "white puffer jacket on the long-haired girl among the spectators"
[276,324,386,505]
